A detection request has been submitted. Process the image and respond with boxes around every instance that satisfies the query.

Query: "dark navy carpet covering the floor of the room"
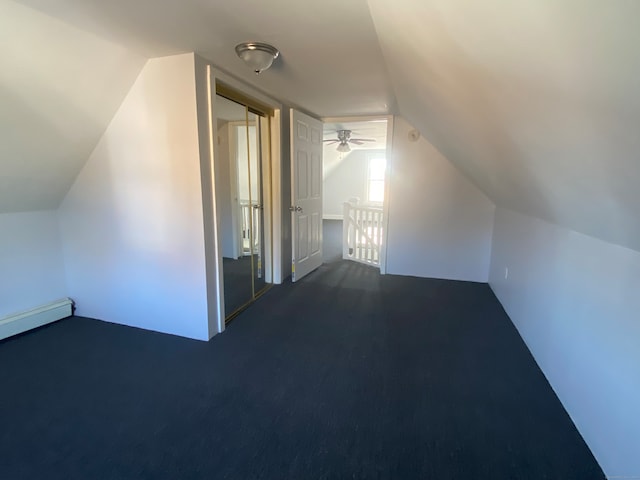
[0,261,604,480]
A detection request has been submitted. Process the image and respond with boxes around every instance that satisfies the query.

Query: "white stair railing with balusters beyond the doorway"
[342,202,383,267]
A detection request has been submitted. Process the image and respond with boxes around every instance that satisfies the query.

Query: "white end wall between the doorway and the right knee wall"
[387,117,495,282]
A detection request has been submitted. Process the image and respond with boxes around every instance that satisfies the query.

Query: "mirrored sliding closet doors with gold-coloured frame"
[215,94,269,321]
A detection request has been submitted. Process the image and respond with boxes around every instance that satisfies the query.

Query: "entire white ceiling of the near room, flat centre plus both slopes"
[0,0,640,250]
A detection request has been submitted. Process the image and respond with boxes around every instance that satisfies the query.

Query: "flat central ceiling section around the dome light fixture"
[13,0,394,116]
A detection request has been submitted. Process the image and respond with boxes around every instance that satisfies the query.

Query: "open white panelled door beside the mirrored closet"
[290,109,322,282]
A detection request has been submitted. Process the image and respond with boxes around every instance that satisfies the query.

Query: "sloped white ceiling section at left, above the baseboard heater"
[0,0,146,213]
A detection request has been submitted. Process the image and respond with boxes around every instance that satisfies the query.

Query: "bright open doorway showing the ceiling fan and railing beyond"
[323,116,392,273]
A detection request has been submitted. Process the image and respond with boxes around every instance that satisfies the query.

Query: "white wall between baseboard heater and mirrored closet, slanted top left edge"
[60,54,209,340]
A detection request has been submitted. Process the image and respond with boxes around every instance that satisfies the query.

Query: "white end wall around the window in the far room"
[322,147,386,218]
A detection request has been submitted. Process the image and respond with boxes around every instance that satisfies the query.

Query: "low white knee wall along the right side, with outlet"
[489,208,640,478]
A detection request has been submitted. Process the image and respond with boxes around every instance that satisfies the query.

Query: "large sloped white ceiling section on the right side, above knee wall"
[369,0,640,250]
